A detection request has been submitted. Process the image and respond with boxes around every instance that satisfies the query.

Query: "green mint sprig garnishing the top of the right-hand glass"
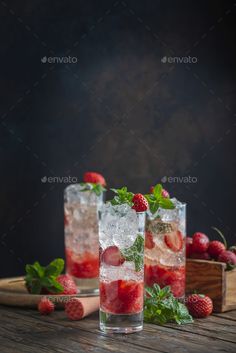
[145,184,175,214]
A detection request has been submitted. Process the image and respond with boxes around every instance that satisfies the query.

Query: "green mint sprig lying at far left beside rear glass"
[25,259,64,294]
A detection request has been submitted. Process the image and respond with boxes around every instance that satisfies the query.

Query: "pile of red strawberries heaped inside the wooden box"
[186,227,236,270]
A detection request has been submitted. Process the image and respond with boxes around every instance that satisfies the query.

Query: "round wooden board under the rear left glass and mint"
[0,277,91,308]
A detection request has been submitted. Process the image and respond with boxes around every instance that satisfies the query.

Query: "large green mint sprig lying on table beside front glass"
[144,284,193,325]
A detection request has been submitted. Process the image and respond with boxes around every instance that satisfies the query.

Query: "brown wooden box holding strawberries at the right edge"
[186,259,236,312]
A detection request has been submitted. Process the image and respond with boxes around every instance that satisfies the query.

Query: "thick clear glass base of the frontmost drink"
[100,310,143,333]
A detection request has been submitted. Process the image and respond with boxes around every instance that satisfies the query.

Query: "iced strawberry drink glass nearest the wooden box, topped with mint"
[145,184,186,299]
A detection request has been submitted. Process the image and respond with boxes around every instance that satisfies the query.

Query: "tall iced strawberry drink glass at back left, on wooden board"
[64,173,105,295]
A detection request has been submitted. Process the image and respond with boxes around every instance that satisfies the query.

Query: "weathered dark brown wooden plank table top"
[0,306,236,353]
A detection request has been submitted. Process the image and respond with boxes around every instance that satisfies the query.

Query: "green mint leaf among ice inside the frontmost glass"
[121,234,144,272]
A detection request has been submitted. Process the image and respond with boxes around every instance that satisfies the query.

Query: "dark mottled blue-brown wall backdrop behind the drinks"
[0,0,236,276]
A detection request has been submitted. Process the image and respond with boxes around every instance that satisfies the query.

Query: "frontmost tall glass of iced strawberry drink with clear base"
[99,189,146,333]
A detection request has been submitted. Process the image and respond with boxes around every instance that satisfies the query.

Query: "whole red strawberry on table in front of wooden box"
[186,294,213,318]
